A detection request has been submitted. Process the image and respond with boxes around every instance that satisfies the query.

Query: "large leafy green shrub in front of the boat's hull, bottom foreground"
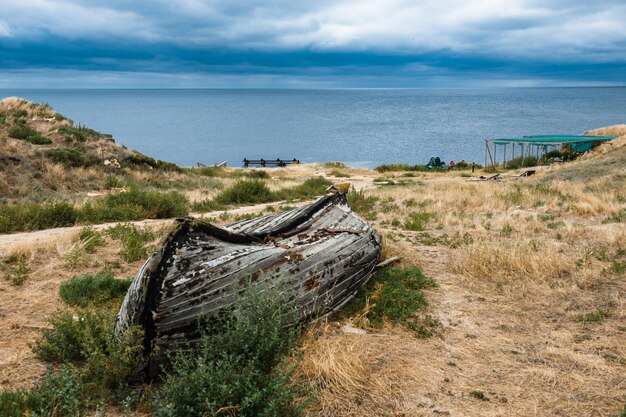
[153,282,302,417]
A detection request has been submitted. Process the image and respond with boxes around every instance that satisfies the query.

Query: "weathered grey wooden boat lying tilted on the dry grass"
[115,185,380,375]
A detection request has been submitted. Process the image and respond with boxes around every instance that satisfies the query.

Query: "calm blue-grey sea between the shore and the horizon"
[0,88,626,167]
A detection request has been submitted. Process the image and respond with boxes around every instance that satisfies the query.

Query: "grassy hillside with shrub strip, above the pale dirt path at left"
[0,98,342,234]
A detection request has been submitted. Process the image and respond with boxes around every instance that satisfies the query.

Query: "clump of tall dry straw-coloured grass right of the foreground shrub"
[296,323,420,417]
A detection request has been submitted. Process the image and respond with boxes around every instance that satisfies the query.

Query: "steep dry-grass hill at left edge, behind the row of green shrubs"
[0,97,181,199]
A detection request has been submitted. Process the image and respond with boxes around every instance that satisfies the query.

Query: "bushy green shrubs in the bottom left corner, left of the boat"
[17,312,145,417]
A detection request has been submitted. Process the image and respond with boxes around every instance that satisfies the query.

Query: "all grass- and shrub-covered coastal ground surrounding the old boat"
[0,99,626,417]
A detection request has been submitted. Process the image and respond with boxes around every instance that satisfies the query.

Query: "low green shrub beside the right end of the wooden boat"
[343,268,436,336]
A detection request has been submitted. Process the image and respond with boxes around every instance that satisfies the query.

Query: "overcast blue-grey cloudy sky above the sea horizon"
[0,0,626,88]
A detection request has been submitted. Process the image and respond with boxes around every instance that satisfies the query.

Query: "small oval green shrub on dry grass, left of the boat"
[59,274,131,307]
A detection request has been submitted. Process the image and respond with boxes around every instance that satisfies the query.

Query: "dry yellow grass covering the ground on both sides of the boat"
[0,127,626,417]
